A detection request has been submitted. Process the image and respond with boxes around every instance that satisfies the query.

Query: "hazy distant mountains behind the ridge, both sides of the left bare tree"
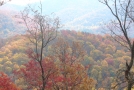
[0,1,134,37]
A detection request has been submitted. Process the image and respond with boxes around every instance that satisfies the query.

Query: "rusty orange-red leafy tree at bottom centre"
[50,54,86,89]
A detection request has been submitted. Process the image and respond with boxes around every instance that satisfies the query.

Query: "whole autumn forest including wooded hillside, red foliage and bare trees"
[0,0,134,90]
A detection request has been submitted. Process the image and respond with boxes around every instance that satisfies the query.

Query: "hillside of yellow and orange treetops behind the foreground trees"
[0,30,133,90]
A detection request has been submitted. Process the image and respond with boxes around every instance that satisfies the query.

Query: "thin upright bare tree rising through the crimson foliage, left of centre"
[21,3,60,90]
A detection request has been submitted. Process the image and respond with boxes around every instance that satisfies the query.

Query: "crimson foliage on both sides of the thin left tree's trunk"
[14,58,57,89]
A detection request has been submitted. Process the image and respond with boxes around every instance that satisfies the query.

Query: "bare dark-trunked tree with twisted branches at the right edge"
[99,0,134,90]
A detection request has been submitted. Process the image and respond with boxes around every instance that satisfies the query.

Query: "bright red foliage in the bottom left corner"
[0,72,20,90]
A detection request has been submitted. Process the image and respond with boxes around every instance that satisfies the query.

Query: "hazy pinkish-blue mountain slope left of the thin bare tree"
[0,10,25,37]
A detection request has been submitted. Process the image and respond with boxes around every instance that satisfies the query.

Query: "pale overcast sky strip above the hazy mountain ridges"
[7,0,104,12]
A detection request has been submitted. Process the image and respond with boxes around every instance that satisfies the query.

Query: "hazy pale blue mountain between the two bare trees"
[56,8,112,33]
